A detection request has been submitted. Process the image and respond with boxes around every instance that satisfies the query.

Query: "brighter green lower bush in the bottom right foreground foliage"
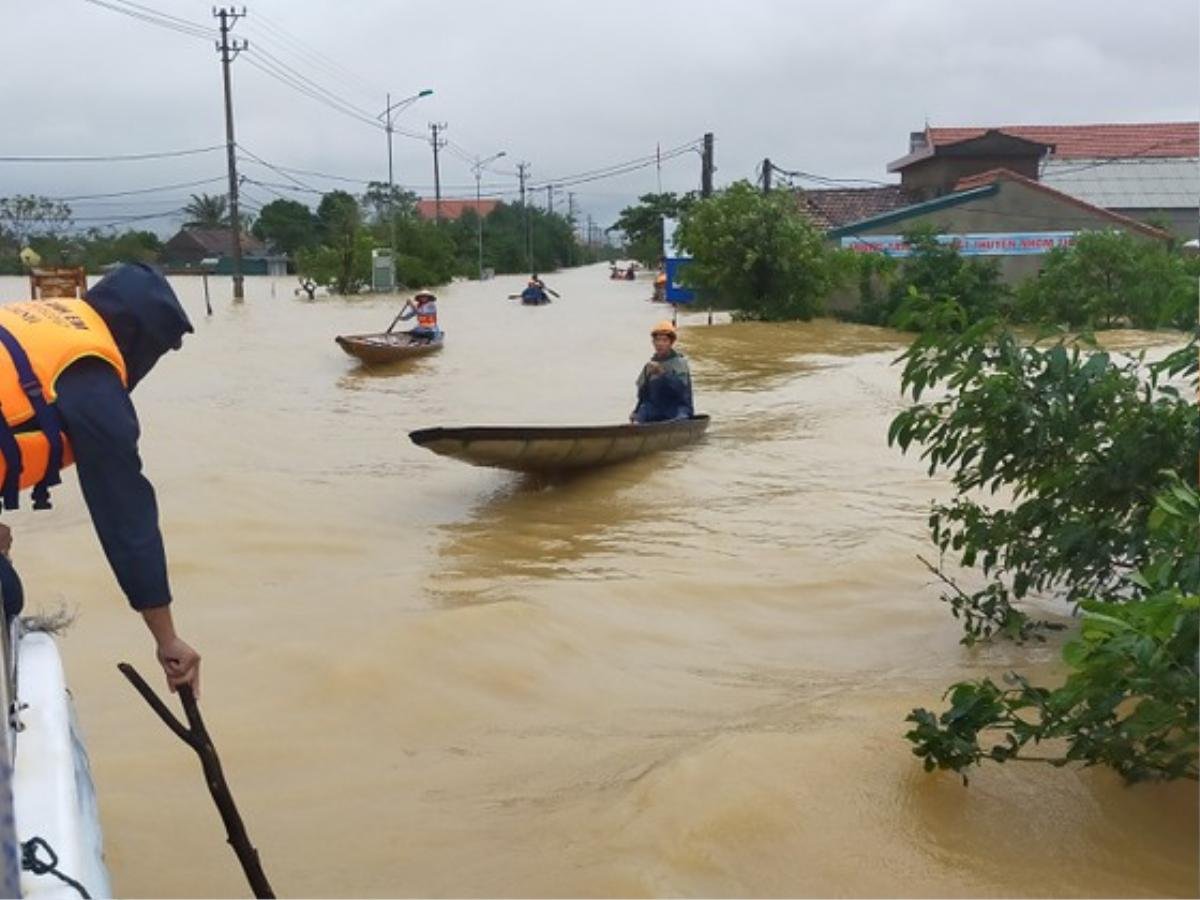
[905,478,1200,782]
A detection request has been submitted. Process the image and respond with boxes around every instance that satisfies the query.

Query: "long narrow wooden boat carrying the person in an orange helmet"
[408,415,708,474]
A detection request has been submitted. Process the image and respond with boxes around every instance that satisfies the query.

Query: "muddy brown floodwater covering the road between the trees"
[0,266,1198,896]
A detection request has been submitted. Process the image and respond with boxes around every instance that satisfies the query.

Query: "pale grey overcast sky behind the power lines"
[0,0,1200,233]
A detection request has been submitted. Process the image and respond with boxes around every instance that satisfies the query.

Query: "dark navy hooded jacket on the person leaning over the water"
[48,265,192,610]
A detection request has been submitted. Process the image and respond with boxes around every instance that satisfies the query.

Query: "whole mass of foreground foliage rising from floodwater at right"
[888,301,1200,779]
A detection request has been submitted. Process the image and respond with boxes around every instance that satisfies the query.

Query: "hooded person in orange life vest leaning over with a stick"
[0,265,200,694]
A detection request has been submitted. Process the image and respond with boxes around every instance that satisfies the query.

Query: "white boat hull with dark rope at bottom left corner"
[0,623,113,900]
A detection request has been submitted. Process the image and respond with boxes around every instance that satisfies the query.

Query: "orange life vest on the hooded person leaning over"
[0,299,128,509]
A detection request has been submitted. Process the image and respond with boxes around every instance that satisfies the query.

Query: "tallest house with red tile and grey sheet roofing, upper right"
[888,122,1200,238]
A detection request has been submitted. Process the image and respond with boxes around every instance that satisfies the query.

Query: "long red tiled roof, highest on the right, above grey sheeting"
[925,122,1200,160]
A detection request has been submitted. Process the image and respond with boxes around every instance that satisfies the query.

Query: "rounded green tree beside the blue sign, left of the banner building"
[677,181,844,320]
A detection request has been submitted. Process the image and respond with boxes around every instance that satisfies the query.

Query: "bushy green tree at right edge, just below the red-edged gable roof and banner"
[1019,230,1198,328]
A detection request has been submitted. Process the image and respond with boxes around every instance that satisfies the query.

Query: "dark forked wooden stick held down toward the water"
[116,662,275,898]
